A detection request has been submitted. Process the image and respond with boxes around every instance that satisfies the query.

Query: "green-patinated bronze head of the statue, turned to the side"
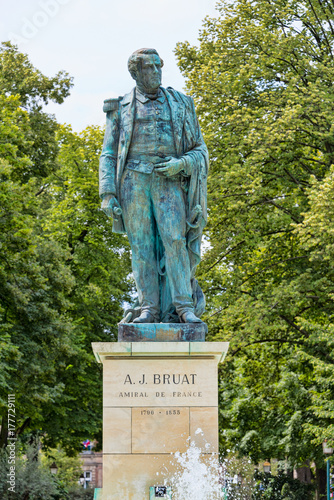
[128,49,164,93]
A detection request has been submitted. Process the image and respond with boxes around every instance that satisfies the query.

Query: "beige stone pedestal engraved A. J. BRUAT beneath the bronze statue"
[92,341,228,500]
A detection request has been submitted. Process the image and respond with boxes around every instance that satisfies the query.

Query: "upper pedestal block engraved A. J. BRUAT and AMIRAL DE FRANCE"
[103,359,218,407]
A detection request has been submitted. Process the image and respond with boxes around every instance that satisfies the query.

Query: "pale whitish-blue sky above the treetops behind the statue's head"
[0,0,216,132]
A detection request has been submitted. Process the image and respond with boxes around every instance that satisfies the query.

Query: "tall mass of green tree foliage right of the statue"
[176,0,334,474]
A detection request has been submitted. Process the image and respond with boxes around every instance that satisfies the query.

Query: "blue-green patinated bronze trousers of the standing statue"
[121,168,193,316]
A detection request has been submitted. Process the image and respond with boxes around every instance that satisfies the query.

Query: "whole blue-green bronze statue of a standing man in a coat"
[100,49,208,323]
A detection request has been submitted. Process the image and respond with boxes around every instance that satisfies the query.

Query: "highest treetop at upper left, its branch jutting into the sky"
[0,42,72,183]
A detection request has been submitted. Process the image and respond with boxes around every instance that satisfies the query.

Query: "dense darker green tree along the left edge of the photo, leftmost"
[0,91,73,450]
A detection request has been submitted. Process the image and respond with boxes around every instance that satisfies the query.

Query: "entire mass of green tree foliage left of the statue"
[0,43,130,454]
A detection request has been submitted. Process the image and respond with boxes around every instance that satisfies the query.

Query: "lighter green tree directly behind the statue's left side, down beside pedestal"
[39,123,131,450]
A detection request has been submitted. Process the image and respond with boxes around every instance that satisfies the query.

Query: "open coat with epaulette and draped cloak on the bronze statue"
[100,87,209,276]
